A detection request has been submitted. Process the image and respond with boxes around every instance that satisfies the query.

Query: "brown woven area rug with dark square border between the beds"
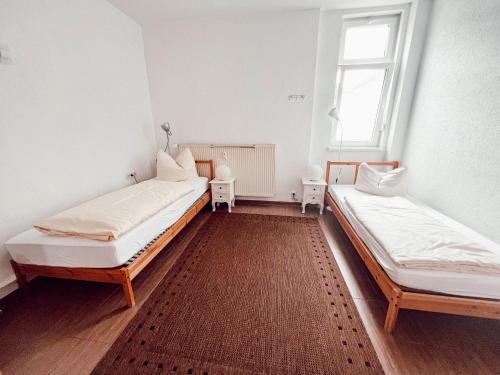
[93,213,383,374]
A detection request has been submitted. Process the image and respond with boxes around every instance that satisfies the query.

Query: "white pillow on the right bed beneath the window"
[355,163,407,196]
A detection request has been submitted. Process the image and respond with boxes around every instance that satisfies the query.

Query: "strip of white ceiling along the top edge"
[108,0,411,24]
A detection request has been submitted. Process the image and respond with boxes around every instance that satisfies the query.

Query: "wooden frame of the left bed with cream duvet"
[10,160,214,307]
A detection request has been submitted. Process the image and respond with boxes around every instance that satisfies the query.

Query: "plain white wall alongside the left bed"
[0,0,156,294]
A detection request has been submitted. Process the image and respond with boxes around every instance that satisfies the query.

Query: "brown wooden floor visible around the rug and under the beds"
[0,204,500,375]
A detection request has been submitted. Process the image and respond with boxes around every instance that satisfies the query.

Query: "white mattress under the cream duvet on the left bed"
[5,177,208,268]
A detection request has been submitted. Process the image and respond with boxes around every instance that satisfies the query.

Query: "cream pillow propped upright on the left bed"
[156,148,198,182]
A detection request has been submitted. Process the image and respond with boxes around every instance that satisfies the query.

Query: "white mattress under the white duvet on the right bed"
[328,185,500,299]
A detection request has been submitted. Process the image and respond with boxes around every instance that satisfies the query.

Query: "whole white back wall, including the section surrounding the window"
[143,4,430,201]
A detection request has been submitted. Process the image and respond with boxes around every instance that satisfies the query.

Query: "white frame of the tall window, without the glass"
[330,7,408,150]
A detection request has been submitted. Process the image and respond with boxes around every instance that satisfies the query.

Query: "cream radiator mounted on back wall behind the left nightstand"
[179,144,274,197]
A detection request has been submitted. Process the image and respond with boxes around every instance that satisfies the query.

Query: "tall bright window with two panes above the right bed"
[332,14,401,147]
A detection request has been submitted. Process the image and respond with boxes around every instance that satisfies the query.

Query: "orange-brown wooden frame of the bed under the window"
[325,161,500,333]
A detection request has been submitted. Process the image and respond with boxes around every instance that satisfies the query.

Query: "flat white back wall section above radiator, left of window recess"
[144,10,318,200]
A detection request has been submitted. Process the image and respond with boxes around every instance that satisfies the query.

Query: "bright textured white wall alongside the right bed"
[404,0,500,243]
